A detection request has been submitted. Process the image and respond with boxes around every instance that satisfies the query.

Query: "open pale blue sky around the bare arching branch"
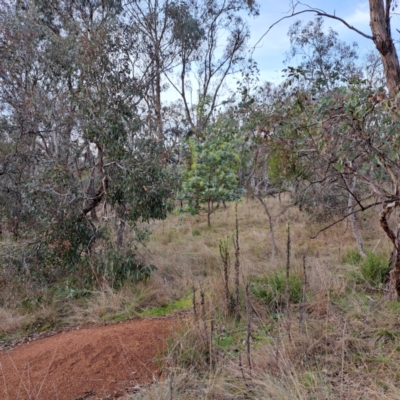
[247,0,374,83]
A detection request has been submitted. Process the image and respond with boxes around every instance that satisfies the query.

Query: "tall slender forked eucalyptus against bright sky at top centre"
[165,0,253,138]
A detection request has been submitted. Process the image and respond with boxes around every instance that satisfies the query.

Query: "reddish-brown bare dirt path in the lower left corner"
[0,318,177,400]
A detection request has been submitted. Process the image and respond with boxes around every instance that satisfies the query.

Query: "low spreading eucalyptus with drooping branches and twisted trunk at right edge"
[262,71,400,299]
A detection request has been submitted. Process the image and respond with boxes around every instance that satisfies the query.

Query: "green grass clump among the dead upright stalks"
[251,268,302,308]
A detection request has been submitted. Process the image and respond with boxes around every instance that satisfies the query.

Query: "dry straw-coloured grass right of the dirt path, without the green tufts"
[126,195,400,400]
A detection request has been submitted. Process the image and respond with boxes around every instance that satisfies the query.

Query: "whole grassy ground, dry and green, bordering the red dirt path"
[0,198,400,400]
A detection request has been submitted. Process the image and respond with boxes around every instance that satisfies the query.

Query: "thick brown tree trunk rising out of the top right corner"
[369,0,400,95]
